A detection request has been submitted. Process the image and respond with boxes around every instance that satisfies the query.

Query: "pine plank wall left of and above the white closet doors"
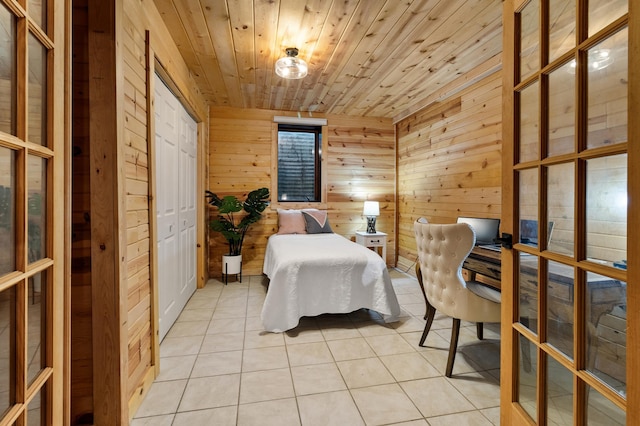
[121,0,208,416]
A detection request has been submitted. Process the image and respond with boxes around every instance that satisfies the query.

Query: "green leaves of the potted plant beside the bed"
[206,188,269,256]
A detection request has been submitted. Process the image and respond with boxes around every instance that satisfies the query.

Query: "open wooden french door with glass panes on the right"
[501,0,640,425]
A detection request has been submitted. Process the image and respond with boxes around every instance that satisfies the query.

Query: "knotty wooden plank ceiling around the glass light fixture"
[154,0,502,119]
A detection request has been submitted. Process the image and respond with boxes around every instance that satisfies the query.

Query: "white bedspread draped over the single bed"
[262,234,400,332]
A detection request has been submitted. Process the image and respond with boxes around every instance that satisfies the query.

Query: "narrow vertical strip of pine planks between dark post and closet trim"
[122,5,152,406]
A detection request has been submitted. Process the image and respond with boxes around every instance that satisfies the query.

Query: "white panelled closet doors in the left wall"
[155,75,197,340]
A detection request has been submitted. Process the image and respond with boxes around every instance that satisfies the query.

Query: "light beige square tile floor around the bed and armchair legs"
[131,270,500,426]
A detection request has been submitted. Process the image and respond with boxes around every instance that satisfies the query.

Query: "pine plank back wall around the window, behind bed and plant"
[208,107,396,277]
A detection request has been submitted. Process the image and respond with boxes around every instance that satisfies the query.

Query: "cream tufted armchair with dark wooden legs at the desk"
[414,218,500,377]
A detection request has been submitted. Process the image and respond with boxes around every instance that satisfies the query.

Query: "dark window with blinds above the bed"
[278,124,322,202]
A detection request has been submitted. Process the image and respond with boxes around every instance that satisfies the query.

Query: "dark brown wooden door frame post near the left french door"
[88,0,129,424]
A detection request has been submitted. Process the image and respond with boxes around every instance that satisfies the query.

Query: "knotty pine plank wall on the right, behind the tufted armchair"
[397,72,502,273]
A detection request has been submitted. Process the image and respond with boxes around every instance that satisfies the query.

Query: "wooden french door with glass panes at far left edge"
[0,0,66,425]
